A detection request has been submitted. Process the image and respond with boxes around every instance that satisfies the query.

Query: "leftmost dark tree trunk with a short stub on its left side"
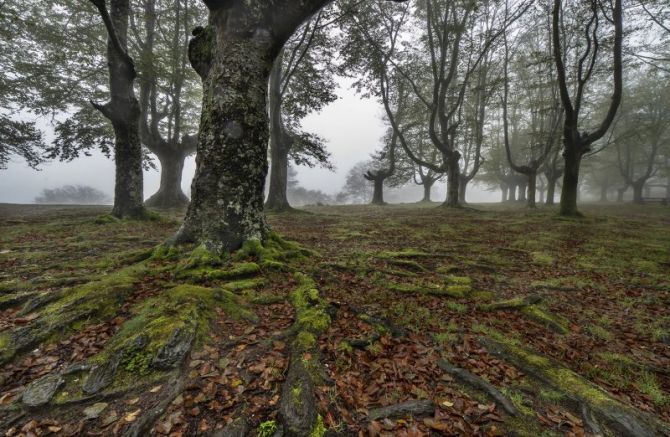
[94,0,144,218]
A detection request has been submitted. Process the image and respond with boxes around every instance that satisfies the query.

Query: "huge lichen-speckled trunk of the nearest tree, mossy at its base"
[174,19,276,253]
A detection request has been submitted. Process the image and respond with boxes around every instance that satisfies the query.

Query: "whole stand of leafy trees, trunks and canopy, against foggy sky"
[0,0,670,251]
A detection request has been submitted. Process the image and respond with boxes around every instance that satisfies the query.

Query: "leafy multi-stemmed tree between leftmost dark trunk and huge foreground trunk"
[139,0,203,208]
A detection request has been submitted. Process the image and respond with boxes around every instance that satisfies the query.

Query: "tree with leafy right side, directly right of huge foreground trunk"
[265,11,337,211]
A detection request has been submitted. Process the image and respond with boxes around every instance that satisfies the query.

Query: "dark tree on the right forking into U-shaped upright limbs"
[552,0,623,216]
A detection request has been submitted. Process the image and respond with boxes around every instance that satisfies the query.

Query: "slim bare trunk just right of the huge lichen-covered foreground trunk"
[265,54,291,211]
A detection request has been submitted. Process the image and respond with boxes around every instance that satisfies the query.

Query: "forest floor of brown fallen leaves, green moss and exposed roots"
[0,205,670,437]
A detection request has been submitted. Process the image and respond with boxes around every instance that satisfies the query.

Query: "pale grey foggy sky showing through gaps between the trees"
[0,81,499,203]
